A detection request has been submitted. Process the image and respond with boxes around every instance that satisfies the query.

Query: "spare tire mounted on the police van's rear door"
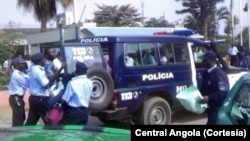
[87,68,114,113]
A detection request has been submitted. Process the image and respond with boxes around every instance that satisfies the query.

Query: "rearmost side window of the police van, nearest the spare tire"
[124,43,158,67]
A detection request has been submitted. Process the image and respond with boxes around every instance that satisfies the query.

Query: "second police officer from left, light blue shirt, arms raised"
[25,53,51,125]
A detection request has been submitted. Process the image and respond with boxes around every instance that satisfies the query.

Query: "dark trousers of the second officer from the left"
[25,95,51,125]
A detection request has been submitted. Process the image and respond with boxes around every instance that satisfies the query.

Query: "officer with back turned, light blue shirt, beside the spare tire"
[62,61,93,125]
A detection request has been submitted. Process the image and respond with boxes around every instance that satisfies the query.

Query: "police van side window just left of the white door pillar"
[159,43,188,64]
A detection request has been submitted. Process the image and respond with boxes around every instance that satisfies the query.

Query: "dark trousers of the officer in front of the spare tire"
[61,105,89,125]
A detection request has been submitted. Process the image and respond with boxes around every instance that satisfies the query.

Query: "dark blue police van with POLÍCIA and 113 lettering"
[41,29,247,125]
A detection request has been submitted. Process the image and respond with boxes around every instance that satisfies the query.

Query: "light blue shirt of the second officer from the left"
[29,65,49,96]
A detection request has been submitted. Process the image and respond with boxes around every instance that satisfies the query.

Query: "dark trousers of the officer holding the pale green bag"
[207,108,220,125]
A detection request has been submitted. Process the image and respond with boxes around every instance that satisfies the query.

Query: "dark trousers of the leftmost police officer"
[9,95,25,126]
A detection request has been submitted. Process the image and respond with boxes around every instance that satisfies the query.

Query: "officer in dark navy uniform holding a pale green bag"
[200,51,229,125]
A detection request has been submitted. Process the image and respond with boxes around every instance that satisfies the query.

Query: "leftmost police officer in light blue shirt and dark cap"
[8,58,29,126]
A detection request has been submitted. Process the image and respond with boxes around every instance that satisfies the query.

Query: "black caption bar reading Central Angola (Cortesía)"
[131,125,250,141]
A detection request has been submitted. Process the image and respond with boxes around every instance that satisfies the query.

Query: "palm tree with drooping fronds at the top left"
[17,0,73,32]
